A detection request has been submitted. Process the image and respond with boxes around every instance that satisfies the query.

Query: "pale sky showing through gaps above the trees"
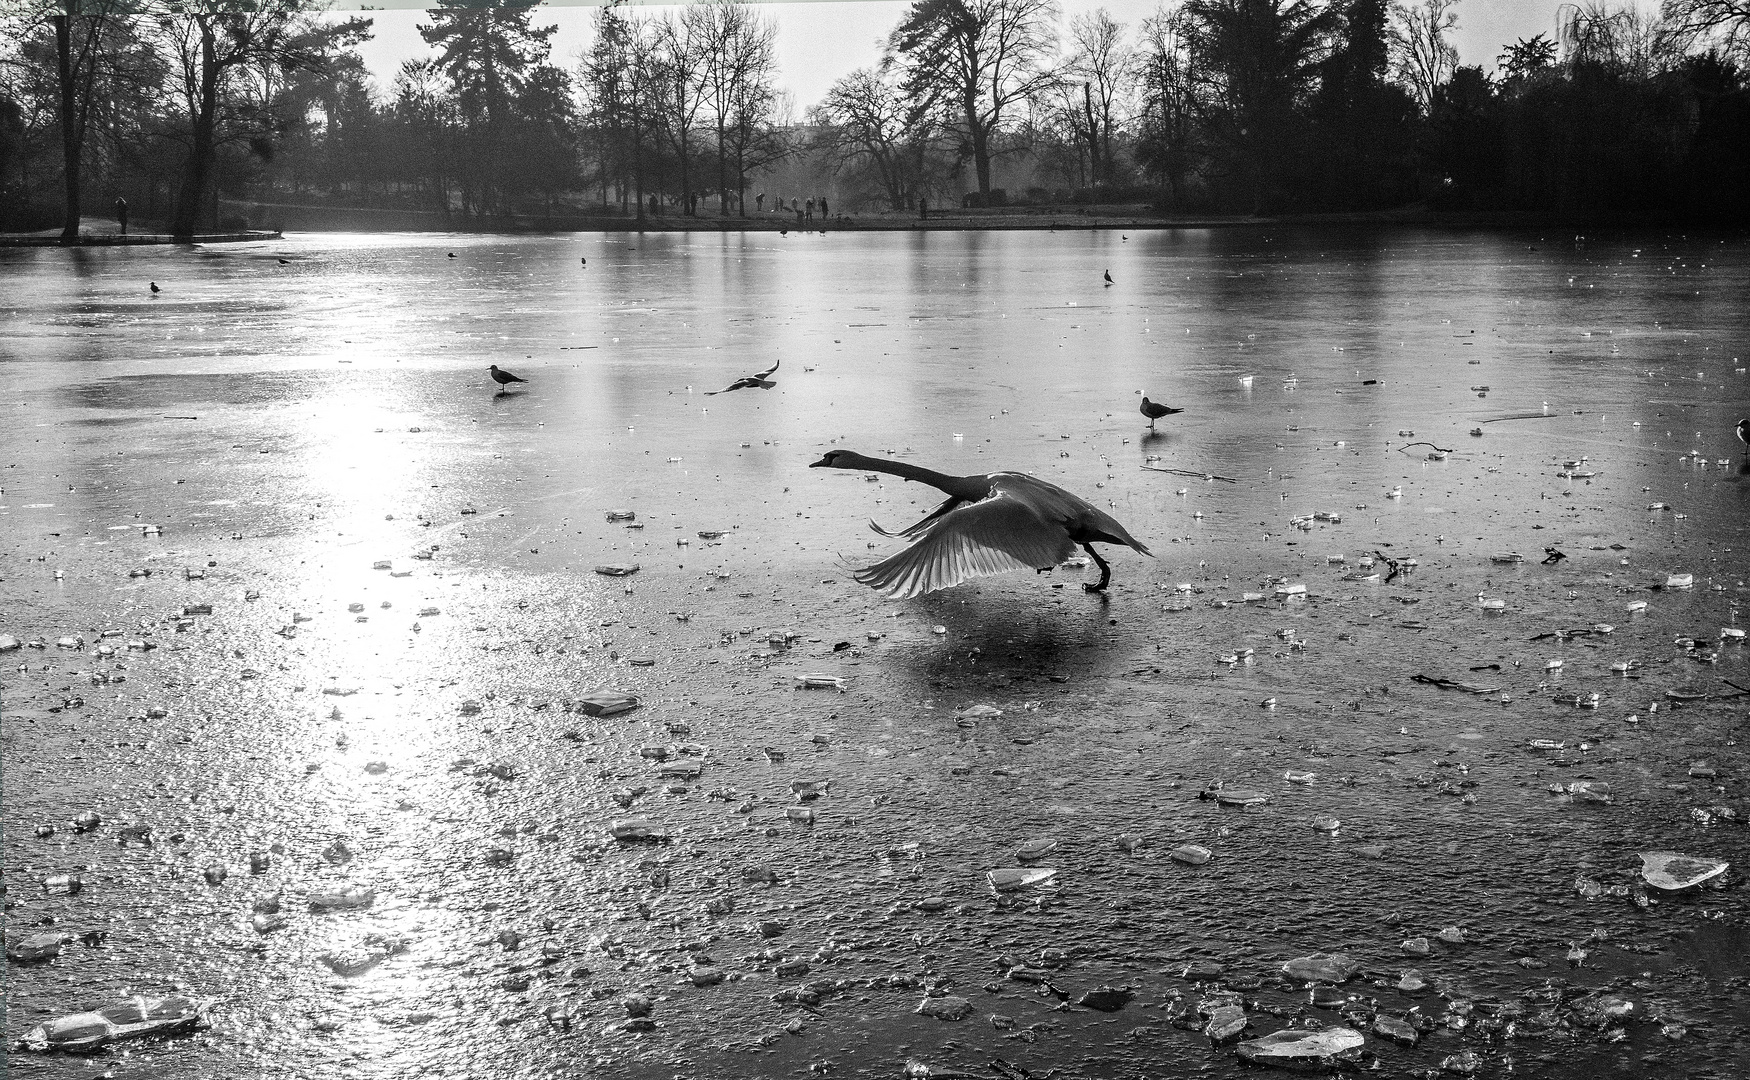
[348,0,1582,114]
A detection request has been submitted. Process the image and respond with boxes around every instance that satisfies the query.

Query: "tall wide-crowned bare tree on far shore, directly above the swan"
[887,0,1057,196]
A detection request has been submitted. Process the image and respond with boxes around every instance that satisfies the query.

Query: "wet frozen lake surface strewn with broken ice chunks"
[0,231,1750,1078]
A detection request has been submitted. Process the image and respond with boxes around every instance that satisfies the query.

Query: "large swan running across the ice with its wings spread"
[809,450,1150,599]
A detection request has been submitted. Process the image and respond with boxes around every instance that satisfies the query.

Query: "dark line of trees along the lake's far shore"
[0,0,1750,235]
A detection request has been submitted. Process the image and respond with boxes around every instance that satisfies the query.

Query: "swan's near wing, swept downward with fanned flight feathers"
[856,492,1076,599]
